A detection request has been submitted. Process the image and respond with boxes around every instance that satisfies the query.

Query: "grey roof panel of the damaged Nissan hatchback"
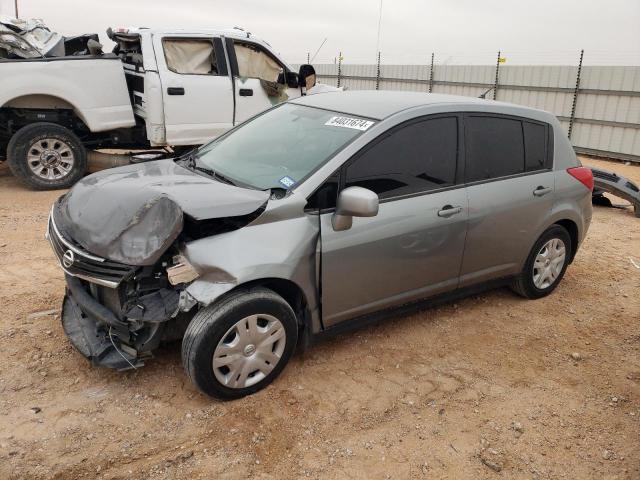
[292,90,544,120]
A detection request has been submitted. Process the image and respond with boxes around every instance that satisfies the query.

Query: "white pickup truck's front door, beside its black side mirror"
[226,38,300,125]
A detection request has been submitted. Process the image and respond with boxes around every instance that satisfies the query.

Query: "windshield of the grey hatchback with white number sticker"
[190,103,373,190]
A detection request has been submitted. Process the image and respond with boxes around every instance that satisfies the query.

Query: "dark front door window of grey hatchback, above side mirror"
[345,117,458,199]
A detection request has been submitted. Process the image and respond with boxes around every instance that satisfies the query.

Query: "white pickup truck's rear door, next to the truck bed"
[154,35,233,145]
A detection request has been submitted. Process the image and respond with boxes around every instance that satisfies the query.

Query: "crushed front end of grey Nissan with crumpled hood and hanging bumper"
[46,161,276,370]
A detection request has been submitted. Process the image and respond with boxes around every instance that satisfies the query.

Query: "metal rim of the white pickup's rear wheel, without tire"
[27,138,75,180]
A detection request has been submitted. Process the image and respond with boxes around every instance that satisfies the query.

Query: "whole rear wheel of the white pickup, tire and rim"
[7,122,87,190]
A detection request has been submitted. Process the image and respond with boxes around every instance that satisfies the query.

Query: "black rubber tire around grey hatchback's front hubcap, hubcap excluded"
[182,287,298,400]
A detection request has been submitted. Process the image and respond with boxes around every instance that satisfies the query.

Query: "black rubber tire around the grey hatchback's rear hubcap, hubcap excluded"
[511,225,574,299]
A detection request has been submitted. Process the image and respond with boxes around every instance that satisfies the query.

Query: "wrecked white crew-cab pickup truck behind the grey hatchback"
[0,21,332,190]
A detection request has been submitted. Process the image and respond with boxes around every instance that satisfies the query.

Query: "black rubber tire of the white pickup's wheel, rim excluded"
[7,122,87,190]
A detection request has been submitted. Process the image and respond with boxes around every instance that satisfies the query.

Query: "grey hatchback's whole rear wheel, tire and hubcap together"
[511,225,573,299]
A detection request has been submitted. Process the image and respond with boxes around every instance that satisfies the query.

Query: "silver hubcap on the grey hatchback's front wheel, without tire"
[213,314,287,388]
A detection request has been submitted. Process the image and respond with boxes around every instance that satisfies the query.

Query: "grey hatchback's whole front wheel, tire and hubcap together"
[182,288,298,399]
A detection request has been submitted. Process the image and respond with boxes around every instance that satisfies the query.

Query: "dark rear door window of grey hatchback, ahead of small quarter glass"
[465,115,525,182]
